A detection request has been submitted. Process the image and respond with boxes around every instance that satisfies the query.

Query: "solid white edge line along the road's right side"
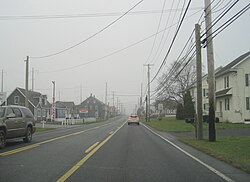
[142,124,234,182]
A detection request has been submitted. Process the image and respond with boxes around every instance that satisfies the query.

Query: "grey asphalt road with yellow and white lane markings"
[0,118,250,182]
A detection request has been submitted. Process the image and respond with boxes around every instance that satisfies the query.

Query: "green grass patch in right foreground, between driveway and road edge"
[180,136,250,173]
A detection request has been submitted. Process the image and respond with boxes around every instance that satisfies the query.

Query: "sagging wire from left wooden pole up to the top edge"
[30,0,144,59]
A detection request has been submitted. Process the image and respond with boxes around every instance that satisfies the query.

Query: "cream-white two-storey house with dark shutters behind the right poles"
[190,52,250,123]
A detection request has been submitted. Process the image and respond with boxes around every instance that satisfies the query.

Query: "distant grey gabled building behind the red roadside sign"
[77,94,107,119]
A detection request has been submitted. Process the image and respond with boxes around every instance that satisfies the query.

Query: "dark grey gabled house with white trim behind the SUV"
[2,87,51,121]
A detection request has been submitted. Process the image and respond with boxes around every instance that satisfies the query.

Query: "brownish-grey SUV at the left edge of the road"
[0,106,36,149]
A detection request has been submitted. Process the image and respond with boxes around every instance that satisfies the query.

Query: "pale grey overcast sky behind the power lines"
[0,0,250,112]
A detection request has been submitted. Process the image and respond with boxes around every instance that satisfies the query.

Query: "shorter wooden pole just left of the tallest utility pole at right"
[195,24,203,140]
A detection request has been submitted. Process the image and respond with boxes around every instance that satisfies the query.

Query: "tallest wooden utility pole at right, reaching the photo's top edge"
[205,0,216,142]
